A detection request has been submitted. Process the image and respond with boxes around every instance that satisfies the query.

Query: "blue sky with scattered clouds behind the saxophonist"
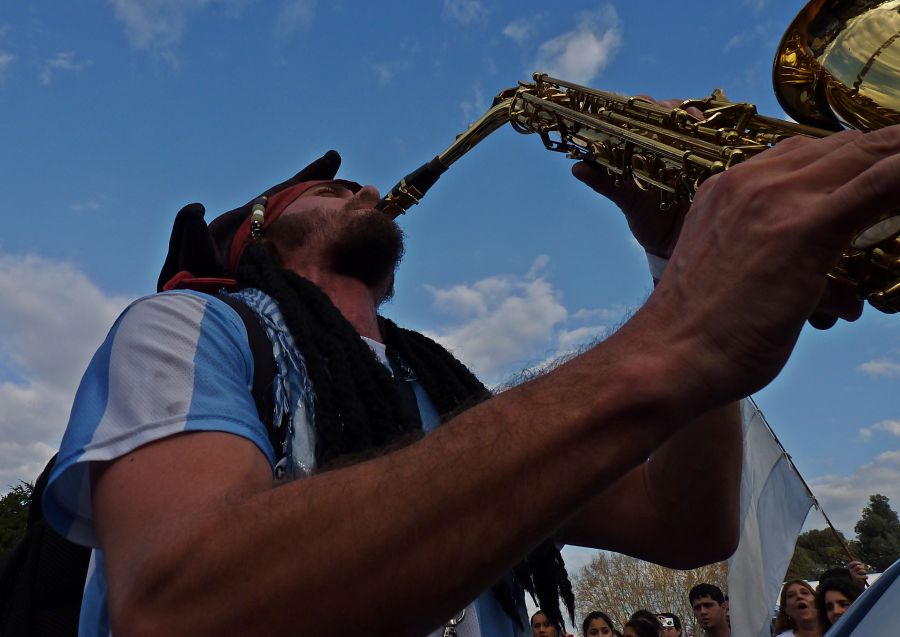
[0,0,900,564]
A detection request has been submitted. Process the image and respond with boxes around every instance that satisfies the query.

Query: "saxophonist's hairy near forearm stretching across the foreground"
[96,316,704,635]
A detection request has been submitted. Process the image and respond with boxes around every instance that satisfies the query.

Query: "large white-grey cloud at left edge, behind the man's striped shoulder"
[0,255,127,492]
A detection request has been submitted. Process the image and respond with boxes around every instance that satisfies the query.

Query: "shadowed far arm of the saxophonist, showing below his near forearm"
[558,403,742,569]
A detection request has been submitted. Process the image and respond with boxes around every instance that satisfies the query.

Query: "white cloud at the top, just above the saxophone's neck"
[534,4,622,84]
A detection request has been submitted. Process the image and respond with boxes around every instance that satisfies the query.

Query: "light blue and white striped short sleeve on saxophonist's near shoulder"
[43,292,274,546]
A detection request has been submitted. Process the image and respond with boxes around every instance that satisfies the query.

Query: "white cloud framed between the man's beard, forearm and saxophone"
[418,256,620,384]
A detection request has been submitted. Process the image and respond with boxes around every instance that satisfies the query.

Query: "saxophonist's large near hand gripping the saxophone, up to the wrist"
[635,126,900,400]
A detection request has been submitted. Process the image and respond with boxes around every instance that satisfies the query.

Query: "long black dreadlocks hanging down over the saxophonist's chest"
[238,240,575,629]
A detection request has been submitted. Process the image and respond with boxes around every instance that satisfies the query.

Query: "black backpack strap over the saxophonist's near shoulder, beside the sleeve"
[216,294,285,462]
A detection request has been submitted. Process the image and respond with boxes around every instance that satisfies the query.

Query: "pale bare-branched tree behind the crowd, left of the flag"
[573,552,728,634]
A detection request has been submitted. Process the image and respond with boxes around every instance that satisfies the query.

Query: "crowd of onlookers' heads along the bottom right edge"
[531,561,866,637]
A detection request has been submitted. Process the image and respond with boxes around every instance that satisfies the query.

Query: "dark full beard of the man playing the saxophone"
[267,201,404,300]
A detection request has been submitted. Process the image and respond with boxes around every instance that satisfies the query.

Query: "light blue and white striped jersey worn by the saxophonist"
[44,290,519,637]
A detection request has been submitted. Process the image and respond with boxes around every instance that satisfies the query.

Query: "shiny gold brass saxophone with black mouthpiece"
[378,0,900,313]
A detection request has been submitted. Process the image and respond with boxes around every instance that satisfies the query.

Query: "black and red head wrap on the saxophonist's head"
[156,150,360,292]
